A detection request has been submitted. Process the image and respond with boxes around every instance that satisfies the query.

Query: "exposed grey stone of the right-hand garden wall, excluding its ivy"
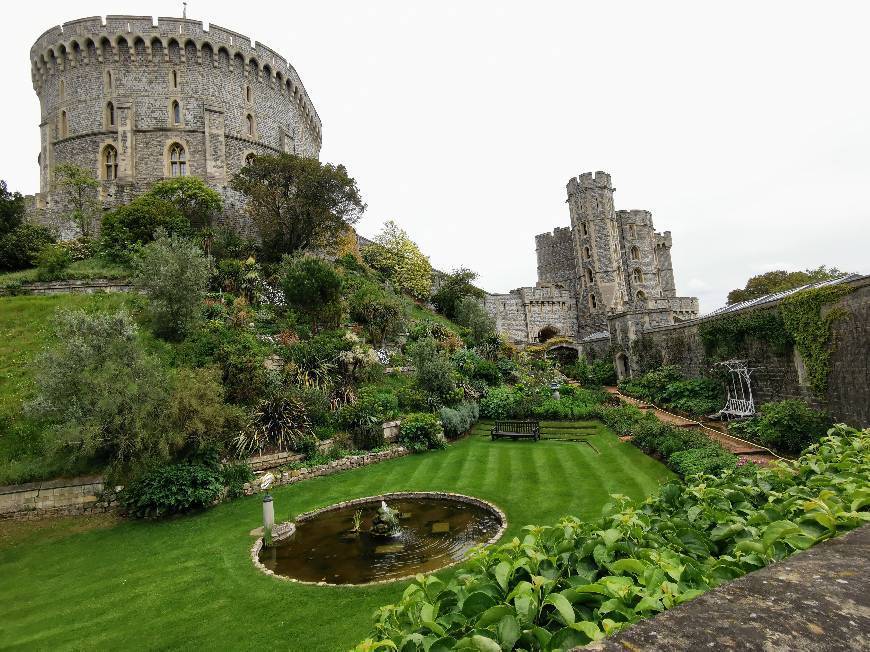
[628,277,870,427]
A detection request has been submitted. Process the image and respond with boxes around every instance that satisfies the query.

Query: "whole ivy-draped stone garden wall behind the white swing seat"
[630,277,870,427]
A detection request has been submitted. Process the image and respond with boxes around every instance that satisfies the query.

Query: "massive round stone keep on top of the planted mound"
[29,16,322,233]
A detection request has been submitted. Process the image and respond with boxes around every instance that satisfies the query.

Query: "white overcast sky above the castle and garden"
[0,0,870,312]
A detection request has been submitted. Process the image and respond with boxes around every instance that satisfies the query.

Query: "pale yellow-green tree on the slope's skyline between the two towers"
[363,220,432,301]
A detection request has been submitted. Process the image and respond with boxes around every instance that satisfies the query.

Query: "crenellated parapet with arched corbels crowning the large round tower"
[30,15,322,140]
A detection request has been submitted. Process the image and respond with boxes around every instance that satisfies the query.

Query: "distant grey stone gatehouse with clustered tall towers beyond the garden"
[486,172,698,343]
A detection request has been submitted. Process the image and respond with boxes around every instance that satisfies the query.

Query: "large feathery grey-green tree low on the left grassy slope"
[30,310,179,479]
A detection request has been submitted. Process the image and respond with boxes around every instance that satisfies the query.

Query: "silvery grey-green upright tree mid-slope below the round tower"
[133,232,209,339]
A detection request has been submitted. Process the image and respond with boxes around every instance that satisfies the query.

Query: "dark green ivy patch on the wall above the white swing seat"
[698,310,794,358]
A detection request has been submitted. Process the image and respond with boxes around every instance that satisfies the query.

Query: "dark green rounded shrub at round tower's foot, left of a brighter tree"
[100,193,190,262]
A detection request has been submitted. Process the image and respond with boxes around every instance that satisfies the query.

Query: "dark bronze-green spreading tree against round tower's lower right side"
[230,154,365,261]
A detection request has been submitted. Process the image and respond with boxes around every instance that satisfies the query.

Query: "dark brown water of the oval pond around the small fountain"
[260,496,502,584]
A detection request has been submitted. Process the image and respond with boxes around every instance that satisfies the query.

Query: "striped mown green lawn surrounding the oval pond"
[0,422,673,652]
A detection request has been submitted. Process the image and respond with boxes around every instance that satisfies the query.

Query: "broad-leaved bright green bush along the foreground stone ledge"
[356,425,870,652]
